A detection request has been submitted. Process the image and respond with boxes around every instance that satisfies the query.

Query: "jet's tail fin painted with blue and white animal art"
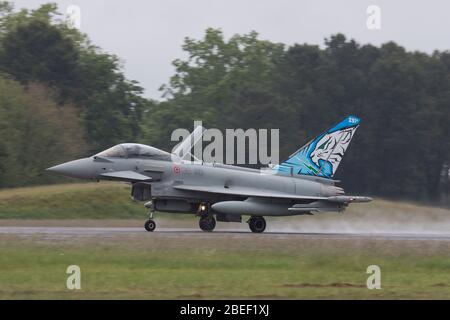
[274,116,360,178]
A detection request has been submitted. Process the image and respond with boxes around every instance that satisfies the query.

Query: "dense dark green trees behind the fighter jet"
[0,2,450,205]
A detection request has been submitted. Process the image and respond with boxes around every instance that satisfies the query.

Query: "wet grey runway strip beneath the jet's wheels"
[0,226,450,241]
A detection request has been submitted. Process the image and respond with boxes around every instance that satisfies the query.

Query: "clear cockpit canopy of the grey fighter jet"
[95,143,171,161]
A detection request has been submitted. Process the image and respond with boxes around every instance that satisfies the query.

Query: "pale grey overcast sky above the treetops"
[13,0,450,99]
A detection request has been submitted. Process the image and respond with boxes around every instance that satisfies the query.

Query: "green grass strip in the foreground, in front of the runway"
[0,235,450,299]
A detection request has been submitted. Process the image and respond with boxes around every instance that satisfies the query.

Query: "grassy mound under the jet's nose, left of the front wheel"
[0,183,145,219]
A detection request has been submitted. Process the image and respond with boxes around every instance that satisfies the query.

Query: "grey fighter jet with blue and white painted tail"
[47,116,372,233]
